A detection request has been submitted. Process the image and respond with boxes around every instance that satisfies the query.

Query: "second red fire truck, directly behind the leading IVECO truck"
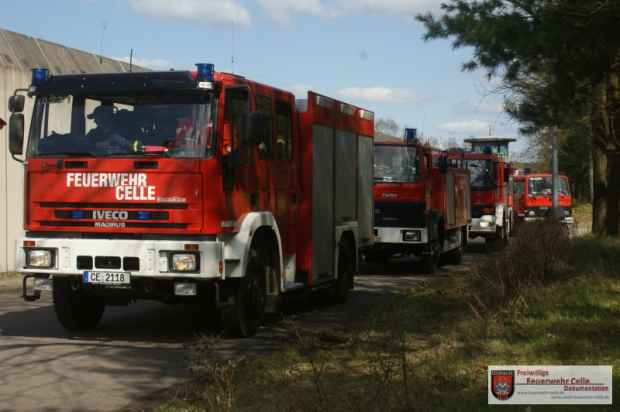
[367,129,470,273]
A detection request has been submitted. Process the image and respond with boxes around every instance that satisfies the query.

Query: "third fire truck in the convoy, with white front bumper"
[450,138,516,245]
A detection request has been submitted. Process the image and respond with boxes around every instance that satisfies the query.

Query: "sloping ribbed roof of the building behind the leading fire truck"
[0,29,147,74]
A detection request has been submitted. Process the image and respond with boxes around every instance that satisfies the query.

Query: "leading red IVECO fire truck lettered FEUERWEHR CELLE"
[9,64,374,337]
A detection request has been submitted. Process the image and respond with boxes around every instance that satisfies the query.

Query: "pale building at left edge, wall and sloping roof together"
[0,29,144,273]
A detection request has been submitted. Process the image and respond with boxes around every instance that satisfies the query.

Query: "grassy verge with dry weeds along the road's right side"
[158,225,620,412]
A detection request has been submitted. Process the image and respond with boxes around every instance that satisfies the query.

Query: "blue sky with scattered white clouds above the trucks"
[0,0,523,147]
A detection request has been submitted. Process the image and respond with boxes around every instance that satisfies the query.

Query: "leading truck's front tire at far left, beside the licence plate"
[52,278,105,331]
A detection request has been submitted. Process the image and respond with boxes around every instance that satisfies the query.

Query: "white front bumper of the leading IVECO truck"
[16,238,224,279]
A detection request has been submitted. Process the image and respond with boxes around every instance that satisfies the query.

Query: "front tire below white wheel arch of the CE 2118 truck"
[222,253,267,338]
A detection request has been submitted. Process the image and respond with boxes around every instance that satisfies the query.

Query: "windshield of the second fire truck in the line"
[375,145,418,183]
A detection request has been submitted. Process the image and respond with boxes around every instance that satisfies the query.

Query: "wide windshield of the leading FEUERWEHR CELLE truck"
[29,94,215,158]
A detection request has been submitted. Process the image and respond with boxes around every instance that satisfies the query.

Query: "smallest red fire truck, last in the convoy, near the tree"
[514,173,574,224]
